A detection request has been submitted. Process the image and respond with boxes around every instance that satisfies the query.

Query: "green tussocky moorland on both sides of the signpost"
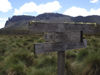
[0,35,100,75]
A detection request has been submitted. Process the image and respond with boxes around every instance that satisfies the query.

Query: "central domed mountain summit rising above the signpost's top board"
[35,13,72,22]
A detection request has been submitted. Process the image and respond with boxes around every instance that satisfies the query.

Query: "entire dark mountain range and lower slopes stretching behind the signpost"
[0,13,97,35]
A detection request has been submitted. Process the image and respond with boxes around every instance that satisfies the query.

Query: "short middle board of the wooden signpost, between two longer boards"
[44,31,81,43]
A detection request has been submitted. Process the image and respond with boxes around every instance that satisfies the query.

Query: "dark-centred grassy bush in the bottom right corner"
[82,53,100,75]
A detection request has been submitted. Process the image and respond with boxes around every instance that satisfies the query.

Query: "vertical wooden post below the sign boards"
[58,51,65,75]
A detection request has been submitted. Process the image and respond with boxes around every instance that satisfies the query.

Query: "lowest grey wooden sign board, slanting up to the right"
[35,39,87,54]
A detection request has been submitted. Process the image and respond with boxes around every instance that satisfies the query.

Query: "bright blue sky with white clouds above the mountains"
[0,0,100,28]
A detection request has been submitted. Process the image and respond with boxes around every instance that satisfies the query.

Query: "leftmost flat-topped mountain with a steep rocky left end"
[4,15,35,30]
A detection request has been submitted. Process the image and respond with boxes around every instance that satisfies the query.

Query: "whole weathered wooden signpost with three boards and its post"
[29,22,94,75]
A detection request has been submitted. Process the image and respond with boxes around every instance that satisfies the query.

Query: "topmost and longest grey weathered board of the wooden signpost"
[28,22,95,33]
